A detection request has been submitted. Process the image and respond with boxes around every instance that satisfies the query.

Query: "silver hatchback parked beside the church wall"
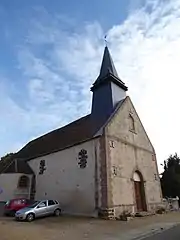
[15,200,61,222]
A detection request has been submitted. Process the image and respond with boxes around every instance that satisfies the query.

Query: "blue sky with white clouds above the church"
[0,0,180,172]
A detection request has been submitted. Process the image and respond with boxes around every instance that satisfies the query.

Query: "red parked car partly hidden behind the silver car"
[4,198,34,216]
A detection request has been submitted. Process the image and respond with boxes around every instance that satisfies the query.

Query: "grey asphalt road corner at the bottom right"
[144,225,180,240]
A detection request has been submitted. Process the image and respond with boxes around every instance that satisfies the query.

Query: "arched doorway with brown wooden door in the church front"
[133,171,147,212]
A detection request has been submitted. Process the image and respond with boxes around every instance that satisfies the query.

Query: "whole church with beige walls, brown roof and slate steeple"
[0,46,162,218]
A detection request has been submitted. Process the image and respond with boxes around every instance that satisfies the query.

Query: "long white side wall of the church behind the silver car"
[28,140,96,215]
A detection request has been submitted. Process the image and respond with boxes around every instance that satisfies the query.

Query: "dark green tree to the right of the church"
[161,153,180,197]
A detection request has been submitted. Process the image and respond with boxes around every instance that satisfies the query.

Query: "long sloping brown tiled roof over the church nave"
[16,115,95,159]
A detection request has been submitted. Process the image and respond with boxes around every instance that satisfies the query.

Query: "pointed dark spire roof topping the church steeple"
[91,46,128,91]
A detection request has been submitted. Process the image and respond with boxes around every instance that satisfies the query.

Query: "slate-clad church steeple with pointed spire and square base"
[91,46,128,127]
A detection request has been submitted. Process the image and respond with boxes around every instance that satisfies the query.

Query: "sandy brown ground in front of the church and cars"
[0,212,180,240]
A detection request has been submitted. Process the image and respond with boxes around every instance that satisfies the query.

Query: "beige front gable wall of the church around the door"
[106,97,162,216]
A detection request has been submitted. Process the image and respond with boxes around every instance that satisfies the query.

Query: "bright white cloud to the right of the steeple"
[109,1,180,171]
